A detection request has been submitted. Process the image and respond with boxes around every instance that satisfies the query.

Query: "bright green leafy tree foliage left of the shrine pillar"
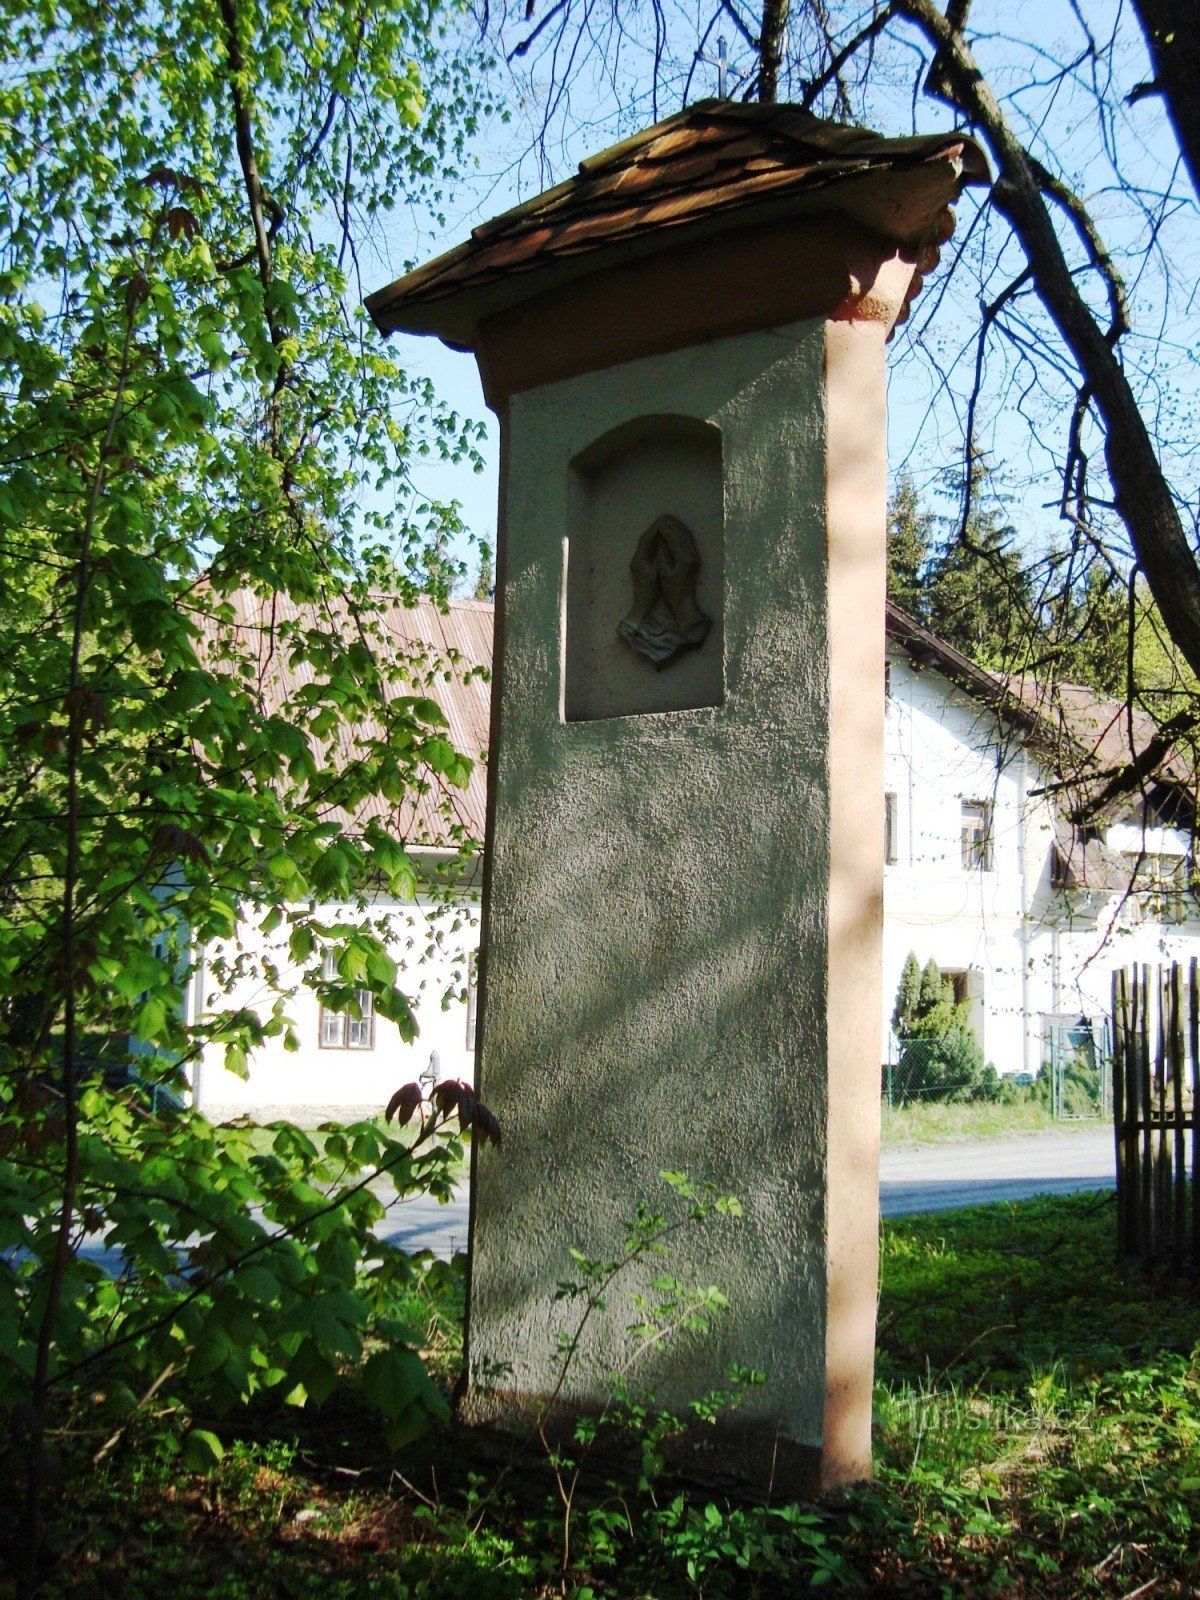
[0,0,492,1589]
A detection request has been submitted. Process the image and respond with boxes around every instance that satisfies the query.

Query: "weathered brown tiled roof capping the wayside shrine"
[366,101,989,347]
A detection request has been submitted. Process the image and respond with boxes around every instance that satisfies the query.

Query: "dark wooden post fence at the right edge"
[1112,958,1200,1272]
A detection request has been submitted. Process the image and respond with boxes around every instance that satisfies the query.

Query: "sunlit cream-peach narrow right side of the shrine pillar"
[821,318,890,1490]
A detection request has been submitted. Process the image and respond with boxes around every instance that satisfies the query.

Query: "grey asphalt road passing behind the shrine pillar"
[379,1125,1115,1256]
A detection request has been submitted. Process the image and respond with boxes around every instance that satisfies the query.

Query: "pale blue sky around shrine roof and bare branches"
[370,0,1200,592]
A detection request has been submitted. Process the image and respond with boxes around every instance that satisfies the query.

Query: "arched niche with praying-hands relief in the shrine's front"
[563,416,725,722]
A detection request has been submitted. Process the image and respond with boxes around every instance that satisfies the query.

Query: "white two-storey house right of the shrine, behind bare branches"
[883,605,1200,1072]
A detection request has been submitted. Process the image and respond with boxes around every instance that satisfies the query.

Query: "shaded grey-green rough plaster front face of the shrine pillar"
[469,322,857,1450]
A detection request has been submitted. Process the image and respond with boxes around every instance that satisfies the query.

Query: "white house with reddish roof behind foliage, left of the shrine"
[197,595,493,1118]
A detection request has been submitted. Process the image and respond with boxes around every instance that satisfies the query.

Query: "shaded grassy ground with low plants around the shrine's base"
[10,1195,1200,1600]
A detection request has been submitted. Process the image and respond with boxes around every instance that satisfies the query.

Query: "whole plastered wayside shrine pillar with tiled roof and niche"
[368,101,987,1493]
